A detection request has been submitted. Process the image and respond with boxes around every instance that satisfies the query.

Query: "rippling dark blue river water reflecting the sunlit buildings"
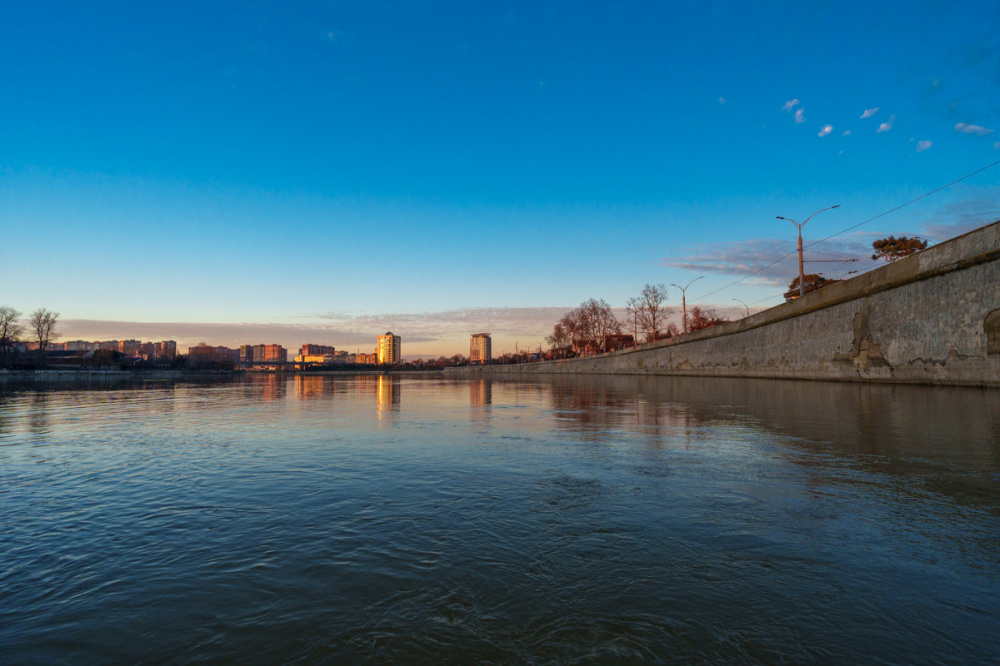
[0,376,1000,664]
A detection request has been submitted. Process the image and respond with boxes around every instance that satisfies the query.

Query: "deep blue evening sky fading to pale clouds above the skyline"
[0,0,1000,358]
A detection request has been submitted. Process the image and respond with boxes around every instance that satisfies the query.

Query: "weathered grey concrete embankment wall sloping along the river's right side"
[449,222,1000,387]
